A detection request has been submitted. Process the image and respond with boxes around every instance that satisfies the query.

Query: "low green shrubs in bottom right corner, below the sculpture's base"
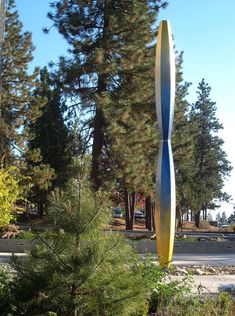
[138,260,235,316]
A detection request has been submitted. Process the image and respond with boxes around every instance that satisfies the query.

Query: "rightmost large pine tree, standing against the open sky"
[190,79,232,226]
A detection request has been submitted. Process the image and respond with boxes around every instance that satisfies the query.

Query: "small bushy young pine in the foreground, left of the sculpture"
[12,170,145,316]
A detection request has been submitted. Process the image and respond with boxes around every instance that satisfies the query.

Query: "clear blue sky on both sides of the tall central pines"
[16,0,235,214]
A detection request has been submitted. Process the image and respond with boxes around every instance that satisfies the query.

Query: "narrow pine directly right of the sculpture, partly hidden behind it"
[172,52,195,228]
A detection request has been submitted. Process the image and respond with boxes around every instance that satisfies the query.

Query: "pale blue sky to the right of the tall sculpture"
[159,0,235,214]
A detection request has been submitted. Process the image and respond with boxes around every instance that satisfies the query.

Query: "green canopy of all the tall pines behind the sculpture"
[0,0,231,229]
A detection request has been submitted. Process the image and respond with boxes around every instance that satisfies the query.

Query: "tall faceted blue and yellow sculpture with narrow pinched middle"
[155,21,175,267]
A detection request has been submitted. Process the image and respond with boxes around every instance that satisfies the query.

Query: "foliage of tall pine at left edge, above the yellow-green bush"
[0,0,56,215]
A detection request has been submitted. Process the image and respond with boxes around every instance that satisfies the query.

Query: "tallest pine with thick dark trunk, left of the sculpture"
[46,0,165,190]
